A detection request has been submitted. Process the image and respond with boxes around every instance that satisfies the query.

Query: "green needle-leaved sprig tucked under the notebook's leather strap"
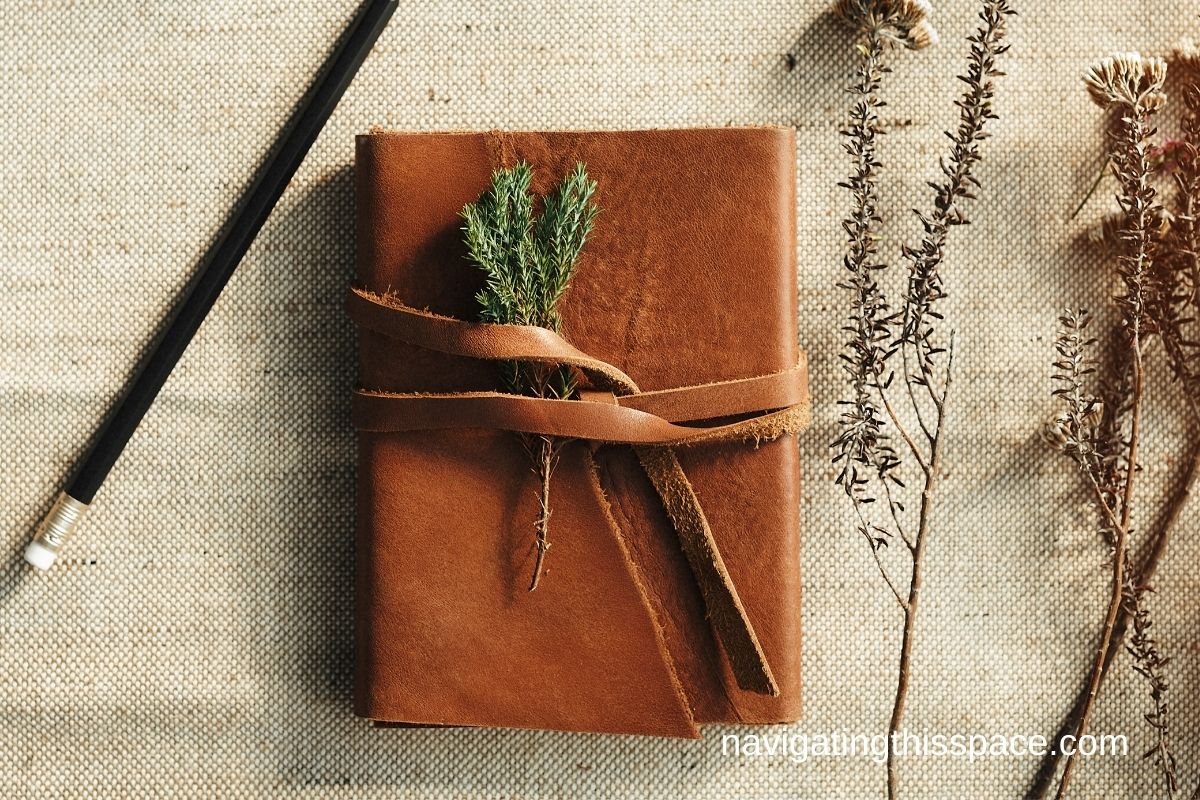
[462,162,598,591]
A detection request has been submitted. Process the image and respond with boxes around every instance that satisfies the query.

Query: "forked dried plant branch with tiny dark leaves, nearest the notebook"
[832,0,1015,800]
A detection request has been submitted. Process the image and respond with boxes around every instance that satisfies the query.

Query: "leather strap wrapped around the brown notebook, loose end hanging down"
[347,288,809,696]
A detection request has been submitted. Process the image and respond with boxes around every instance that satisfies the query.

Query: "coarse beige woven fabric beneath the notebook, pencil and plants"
[0,0,1200,800]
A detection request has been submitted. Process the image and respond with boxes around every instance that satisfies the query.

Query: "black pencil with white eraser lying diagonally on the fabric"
[25,0,397,570]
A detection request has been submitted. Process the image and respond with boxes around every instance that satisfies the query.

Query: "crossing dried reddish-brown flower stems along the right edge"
[1034,53,1200,800]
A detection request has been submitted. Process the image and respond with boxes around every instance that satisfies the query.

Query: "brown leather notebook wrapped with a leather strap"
[350,128,806,736]
